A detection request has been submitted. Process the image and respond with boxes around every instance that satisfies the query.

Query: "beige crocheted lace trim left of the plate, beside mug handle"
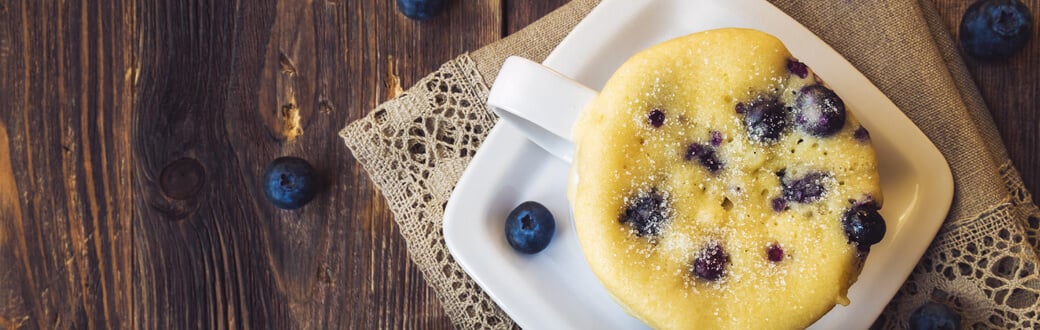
[340,54,515,329]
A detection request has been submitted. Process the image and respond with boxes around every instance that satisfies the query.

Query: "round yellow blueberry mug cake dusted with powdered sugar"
[569,28,885,329]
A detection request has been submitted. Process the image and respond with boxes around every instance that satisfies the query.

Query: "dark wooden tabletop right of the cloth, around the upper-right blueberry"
[934,0,1040,202]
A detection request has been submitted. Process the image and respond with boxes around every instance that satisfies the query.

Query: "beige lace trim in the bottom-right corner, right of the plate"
[874,162,1040,329]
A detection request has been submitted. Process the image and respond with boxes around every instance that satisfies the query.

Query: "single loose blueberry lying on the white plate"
[505,201,556,254]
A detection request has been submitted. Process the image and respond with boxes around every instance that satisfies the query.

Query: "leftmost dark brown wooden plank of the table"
[0,1,135,329]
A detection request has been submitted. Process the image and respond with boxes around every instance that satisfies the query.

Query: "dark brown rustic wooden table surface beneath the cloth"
[0,0,1040,329]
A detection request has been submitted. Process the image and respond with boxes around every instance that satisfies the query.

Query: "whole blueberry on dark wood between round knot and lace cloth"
[263,157,318,209]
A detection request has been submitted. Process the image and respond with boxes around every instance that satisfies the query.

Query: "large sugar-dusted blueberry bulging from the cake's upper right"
[795,84,846,136]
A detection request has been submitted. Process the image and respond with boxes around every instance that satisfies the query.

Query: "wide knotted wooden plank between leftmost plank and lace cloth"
[127,0,500,329]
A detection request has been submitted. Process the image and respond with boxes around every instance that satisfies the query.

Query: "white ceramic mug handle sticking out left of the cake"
[488,56,597,162]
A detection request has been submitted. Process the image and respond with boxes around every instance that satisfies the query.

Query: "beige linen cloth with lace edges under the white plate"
[340,0,1040,329]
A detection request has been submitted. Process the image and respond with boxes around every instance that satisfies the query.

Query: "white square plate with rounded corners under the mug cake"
[444,0,953,329]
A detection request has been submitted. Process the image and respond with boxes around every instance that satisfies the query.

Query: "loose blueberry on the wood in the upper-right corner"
[960,0,1033,60]
